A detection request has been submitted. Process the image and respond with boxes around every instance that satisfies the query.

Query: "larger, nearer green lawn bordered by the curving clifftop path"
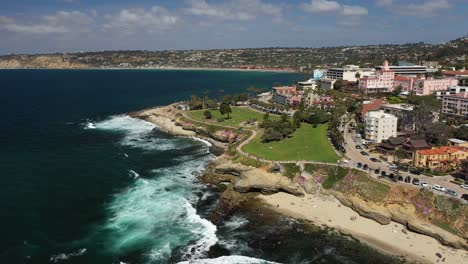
[243,123,339,163]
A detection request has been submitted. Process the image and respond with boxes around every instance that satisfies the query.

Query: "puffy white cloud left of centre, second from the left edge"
[103,6,180,33]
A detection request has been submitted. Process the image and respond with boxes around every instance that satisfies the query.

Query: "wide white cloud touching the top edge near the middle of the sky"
[184,0,282,21]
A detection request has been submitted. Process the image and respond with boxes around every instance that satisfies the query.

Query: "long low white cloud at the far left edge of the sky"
[0,11,94,34]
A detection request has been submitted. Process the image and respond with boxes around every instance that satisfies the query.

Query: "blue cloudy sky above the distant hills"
[0,0,468,54]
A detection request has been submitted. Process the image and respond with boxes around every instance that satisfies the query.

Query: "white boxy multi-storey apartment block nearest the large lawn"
[365,110,398,143]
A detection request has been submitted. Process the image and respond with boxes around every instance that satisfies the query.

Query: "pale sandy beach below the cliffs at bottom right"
[260,193,468,264]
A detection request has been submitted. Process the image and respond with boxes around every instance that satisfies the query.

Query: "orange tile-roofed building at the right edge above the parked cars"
[413,146,468,171]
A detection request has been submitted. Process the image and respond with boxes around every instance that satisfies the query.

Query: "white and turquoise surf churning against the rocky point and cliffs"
[88,116,218,263]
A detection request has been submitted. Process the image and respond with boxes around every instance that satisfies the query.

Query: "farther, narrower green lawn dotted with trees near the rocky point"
[188,107,279,126]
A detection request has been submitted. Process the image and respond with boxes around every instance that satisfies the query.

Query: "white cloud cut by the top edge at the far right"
[377,0,452,17]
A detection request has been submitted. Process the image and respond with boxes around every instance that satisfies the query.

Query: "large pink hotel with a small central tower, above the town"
[359,61,458,95]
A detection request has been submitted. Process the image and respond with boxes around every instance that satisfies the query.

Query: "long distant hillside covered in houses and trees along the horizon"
[0,34,468,71]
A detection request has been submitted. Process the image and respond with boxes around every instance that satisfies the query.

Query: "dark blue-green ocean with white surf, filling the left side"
[0,70,402,264]
